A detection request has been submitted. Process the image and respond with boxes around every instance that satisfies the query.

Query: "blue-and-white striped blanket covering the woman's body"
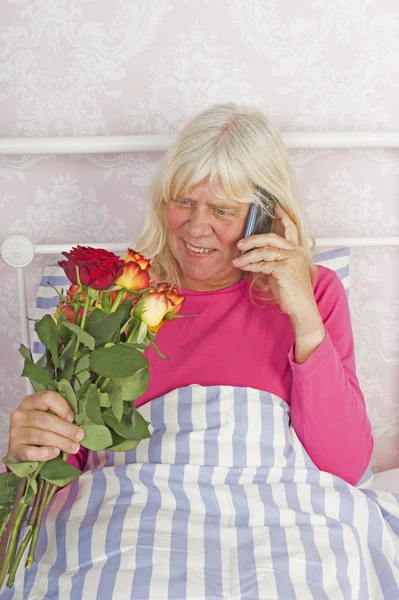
[1,386,399,600]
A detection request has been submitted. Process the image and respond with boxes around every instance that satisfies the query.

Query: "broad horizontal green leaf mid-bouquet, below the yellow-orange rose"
[90,344,148,377]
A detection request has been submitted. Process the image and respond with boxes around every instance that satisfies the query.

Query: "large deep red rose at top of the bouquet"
[58,246,123,290]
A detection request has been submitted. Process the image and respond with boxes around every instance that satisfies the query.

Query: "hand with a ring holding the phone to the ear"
[233,204,320,319]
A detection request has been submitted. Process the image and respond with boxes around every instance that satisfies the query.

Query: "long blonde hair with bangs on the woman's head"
[136,102,316,299]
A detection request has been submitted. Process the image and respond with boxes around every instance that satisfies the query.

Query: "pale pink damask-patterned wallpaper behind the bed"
[0,0,399,470]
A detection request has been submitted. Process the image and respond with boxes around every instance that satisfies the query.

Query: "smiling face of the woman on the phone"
[166,183,249,291]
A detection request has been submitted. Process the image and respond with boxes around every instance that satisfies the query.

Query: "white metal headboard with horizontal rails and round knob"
[0,131,399,393]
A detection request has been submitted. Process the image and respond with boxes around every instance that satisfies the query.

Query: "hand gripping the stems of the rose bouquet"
[7,391,84,462]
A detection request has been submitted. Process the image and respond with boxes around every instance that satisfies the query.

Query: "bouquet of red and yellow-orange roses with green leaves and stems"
[0,246,184,587]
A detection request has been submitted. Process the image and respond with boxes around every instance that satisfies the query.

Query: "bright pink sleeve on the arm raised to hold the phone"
[288,268,373,485]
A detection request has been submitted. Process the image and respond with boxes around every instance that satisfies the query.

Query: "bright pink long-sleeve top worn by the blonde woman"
[69,266,373,485]
